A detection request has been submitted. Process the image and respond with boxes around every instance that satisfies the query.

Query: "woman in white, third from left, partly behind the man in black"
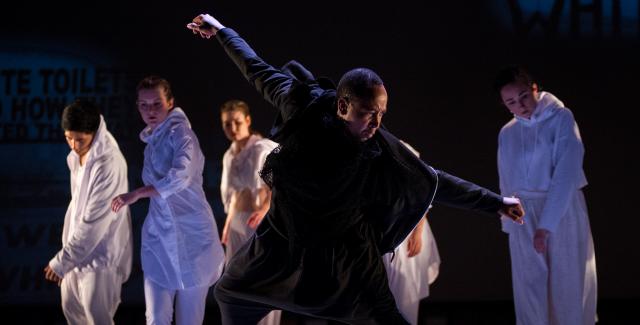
[220,100,282,325]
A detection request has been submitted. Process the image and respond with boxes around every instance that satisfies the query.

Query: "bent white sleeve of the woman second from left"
[153,127,198,199]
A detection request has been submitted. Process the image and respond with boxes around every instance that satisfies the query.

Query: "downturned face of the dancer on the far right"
[500,81,538,119]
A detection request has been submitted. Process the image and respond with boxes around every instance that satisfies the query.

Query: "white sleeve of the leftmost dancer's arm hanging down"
[49,165,122,277]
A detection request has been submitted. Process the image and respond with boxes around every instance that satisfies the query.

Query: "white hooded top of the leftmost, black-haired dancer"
[49,116,133,282]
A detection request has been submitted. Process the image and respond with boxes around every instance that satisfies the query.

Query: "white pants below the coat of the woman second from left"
[144,277,209,325]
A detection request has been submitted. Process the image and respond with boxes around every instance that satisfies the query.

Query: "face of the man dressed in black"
[338,85,387,141]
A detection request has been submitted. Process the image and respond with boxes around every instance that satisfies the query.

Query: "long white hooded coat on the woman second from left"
[140,107,224,290]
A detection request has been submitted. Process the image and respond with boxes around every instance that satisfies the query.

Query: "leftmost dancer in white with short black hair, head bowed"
[44,101,133,324]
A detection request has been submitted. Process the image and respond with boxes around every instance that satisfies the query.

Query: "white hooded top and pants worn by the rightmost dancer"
[498,92,596,324]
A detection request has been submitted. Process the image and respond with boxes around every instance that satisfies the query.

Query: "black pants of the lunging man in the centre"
[214,222,408,325]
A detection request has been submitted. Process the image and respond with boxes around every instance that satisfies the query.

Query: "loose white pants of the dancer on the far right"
[506,191,597,325]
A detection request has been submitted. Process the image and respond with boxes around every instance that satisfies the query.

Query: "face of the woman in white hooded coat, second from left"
[137,86,173,129]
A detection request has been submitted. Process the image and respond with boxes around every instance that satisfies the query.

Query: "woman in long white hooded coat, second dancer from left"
[112,76,224,325]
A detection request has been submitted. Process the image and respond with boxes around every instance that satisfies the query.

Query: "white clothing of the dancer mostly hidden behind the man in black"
[382,142,440,324]
